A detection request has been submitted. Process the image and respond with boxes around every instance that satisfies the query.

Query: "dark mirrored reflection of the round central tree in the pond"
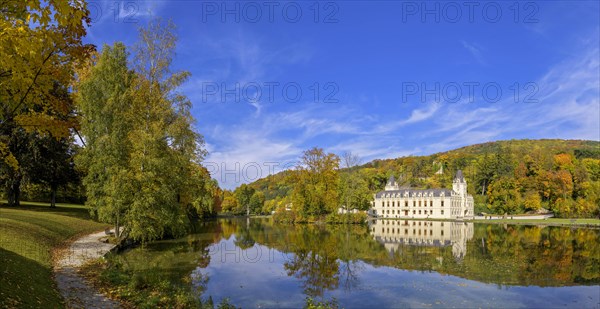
[283,250,339,297]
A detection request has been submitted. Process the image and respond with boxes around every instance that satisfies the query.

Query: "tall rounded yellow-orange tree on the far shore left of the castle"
[292,147,340,215]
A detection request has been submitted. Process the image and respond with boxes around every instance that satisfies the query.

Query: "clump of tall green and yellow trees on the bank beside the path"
[77,20,209,242]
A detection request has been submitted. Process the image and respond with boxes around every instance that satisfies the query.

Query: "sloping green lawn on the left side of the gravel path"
[0,201,108,308]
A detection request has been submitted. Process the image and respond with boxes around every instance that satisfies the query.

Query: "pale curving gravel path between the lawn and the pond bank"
[54,231,121,308]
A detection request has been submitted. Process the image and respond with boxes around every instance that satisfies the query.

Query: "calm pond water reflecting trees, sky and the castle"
[116,218,600,308]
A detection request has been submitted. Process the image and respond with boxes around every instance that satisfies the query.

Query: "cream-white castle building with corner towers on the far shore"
[369,170,473,219]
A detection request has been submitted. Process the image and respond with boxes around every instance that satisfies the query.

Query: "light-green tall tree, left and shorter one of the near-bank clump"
[75,43,134,236]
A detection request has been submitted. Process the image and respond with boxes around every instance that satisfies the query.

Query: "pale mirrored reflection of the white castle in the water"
[369,219,473,259]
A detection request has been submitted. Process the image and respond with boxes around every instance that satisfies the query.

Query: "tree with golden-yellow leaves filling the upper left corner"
[0,0,93,205]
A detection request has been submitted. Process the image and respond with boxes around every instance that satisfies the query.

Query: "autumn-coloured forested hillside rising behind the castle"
[223,140,600,217]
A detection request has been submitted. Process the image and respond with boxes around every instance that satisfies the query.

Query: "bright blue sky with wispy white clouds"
[86,1,600,188]
